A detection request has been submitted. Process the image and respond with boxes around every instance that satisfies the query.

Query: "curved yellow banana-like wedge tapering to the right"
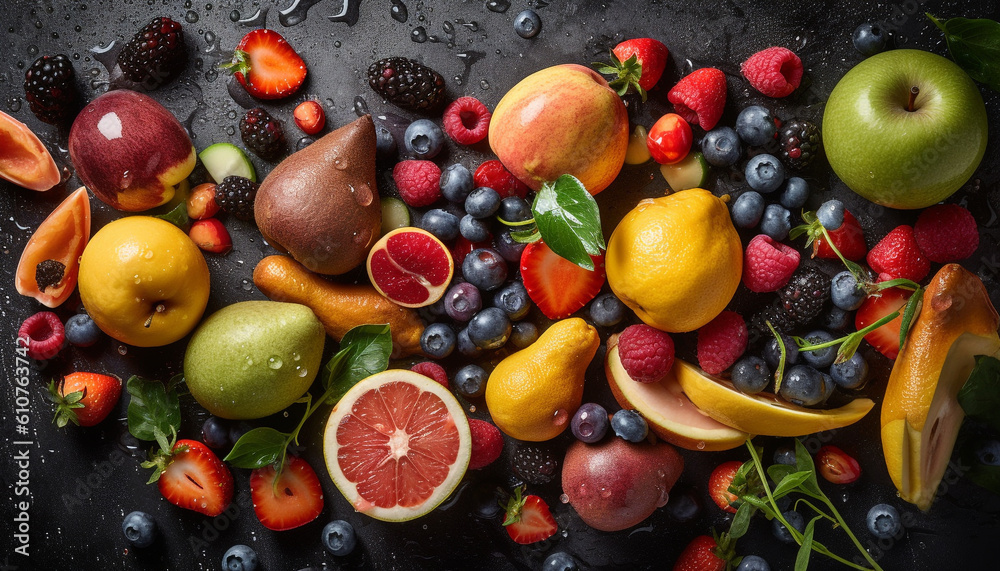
[674,359,875,436]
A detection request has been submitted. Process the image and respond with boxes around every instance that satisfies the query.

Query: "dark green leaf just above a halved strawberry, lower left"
[125,376,181,447]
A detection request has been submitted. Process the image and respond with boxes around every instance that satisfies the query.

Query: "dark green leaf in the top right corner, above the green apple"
[927,14,1000,91]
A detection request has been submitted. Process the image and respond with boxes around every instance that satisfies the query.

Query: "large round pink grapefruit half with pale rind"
[323,369,472,521]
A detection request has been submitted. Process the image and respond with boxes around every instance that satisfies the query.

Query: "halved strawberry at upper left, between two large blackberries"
[222,29,306,99]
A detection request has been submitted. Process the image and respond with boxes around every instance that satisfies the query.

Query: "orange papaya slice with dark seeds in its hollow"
[14,186,90,307]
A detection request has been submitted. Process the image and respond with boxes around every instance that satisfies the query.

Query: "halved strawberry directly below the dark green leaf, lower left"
[158,440,233,517]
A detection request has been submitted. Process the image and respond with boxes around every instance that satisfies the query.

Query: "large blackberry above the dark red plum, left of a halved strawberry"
[117,17,187,89]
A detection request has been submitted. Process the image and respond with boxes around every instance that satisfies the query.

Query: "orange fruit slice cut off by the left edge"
[0,111,62,191]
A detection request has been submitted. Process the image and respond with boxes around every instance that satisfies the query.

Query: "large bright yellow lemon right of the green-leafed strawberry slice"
[605,188,743,332]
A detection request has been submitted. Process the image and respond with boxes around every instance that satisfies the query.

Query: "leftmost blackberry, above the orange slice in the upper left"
[24,54,80,125]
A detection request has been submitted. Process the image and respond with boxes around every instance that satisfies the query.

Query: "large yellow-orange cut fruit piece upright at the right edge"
[882,264,1000,510]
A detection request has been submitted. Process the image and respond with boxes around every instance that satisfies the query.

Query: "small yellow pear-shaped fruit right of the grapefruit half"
[486,317,601,442]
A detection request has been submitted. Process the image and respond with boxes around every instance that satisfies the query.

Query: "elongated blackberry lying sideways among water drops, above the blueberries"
[368,57,445,111]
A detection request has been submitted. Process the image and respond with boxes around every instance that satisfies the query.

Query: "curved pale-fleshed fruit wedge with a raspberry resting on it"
[604,334,752,451]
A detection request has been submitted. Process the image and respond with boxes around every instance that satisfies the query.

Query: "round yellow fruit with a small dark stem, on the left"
[79,216,210,347]
